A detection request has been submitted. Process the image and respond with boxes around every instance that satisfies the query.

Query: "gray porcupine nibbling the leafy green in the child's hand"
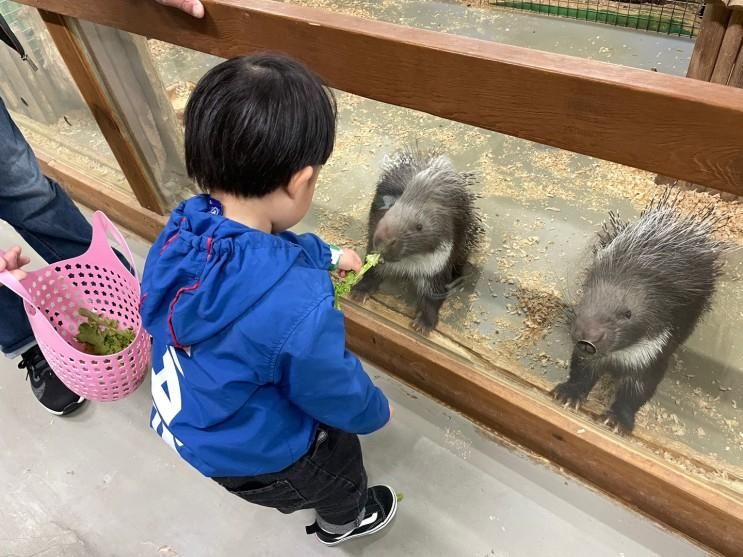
[352,148,483,334]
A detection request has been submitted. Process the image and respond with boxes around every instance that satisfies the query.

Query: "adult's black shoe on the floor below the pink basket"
[18,346,85,416]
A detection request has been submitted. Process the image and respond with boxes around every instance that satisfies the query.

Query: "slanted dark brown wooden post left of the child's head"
[40,10,163,214]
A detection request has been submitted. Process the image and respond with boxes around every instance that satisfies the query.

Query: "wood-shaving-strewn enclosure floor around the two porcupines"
[149,5,743,494]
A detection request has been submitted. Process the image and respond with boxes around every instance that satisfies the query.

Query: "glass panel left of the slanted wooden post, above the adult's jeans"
[0,0,131,192]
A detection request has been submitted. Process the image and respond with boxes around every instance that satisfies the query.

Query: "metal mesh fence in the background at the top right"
[488,0,704,38]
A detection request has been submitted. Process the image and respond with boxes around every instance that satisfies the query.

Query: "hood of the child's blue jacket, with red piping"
[141,196,302,348]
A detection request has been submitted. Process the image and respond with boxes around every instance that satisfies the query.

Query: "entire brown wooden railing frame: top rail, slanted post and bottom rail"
[10,0,743,555]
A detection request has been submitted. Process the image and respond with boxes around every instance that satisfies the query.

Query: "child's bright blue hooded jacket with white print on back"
[142,196,389,477]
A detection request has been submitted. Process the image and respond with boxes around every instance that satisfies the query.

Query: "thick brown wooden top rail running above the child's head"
[13,0,743,195]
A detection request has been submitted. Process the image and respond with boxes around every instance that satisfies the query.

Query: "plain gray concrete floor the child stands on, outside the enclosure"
[0,213,706,557]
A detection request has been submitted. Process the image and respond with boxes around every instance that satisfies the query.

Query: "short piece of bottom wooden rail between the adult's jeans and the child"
[34,150,167,242]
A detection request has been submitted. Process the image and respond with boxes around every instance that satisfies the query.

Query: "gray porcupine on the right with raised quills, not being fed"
[552,190,729,433]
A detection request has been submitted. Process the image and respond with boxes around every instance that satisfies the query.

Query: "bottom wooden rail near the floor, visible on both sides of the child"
[24,161,743,556]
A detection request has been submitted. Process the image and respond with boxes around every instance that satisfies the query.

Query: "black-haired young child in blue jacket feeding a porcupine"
[142,55,397,545]
